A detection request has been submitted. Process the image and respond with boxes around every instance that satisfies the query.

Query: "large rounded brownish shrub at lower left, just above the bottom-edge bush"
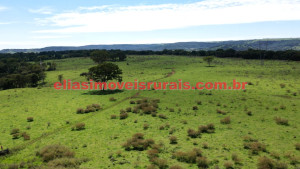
[37,145,75,162]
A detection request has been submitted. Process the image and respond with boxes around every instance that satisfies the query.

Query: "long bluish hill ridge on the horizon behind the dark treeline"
[0,38,300,53]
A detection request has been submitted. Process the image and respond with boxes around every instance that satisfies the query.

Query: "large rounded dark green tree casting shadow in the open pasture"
[81,62,122,82]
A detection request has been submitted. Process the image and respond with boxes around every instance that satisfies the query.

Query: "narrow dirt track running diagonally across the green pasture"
[5,68,175,155]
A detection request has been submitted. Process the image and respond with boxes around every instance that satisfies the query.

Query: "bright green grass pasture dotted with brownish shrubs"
[0,56,300,169]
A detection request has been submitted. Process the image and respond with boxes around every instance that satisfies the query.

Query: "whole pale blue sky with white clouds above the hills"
[0,0,300,49]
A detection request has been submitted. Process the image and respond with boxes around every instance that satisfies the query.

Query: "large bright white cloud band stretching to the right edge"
[30,0,300,33]
